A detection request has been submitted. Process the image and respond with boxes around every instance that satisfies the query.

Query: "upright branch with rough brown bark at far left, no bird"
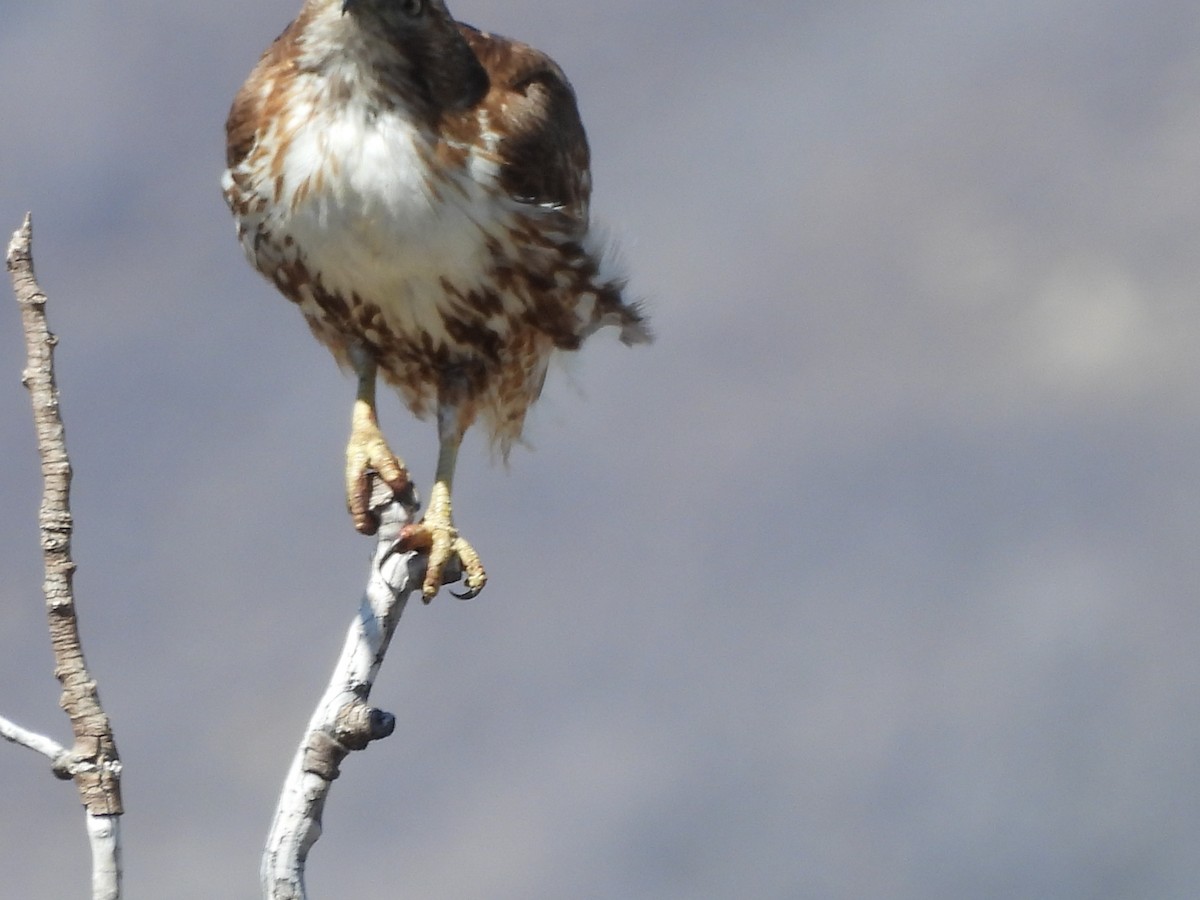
[5,215,122,900]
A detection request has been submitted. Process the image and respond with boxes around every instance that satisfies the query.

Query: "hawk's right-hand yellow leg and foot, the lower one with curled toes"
[401,402,487,602]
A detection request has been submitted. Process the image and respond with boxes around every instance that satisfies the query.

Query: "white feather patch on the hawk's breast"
[271,79,508,336]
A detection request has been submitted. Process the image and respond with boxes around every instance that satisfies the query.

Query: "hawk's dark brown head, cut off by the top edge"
[341,0,488,112]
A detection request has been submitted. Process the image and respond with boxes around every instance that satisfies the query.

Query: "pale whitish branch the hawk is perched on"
[262,479,426,900]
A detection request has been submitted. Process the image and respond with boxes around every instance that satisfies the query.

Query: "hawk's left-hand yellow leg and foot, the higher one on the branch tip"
[346,347,408,534]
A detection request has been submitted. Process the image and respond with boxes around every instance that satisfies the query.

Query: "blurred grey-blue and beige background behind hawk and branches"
[0,0,1200,900]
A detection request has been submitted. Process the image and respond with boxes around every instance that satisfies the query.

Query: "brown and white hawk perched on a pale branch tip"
[222,0,649,602]
